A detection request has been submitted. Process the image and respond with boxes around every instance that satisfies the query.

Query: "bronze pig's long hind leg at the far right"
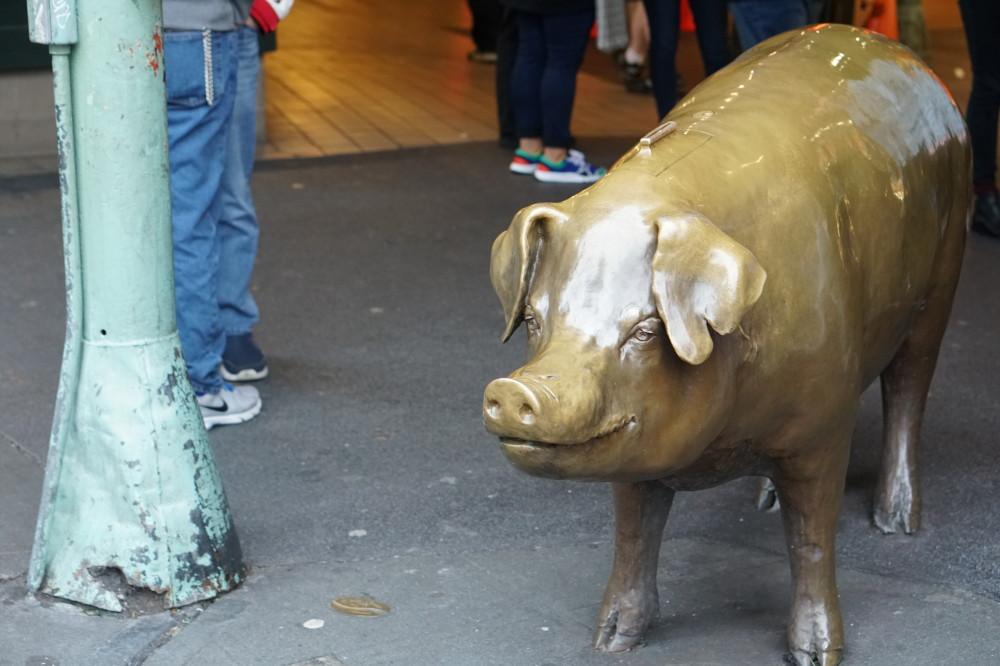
[872,218,965,534]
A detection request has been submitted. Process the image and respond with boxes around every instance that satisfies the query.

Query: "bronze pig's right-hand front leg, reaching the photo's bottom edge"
[774,446,853,666]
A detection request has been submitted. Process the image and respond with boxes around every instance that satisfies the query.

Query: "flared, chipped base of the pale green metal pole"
[28,333,245,611]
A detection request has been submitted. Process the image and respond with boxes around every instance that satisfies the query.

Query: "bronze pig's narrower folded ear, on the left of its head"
[490,204,566,342]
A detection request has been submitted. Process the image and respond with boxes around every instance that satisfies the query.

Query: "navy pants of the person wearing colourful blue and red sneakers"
[512,10,594,148]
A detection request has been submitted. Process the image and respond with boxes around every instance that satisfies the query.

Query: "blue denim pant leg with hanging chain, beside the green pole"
[164,31,236,392]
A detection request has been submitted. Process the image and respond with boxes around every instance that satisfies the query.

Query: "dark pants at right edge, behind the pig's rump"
[958,0,1000,193]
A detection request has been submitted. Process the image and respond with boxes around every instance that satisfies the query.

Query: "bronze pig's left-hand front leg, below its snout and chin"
[594,481,674,652]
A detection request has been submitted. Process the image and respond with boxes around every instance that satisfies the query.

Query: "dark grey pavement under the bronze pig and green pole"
[0,140,1000,666]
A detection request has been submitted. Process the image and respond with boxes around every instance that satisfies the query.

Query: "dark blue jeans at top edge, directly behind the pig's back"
[643,0,732,118]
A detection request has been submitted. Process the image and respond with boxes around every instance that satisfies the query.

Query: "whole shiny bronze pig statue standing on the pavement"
[483,25,970,666]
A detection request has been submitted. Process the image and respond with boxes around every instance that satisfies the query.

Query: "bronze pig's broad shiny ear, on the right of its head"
[653,215,767,365]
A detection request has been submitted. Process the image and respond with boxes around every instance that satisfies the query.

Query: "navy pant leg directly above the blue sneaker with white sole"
[541,9,594,148]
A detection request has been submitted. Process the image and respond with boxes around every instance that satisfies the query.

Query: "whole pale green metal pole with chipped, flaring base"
[28,0,244,611]
